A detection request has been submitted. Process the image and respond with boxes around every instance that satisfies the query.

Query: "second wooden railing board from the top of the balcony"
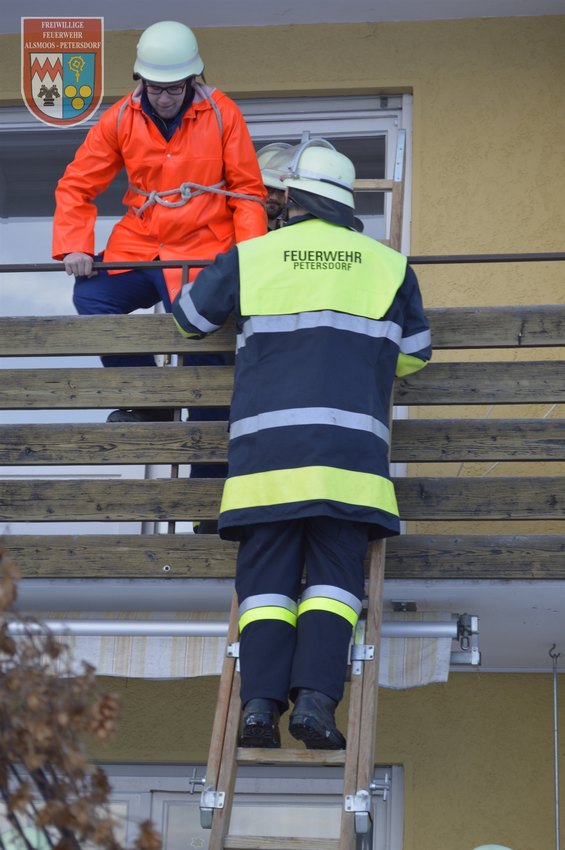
[0,360,565,410]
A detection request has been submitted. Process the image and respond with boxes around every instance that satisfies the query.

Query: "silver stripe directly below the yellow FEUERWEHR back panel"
[237,310,402,350]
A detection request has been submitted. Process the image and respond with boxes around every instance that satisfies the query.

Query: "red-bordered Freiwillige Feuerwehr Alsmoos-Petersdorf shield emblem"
[22,16,104,127]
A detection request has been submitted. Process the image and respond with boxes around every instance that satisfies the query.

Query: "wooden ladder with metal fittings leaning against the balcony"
[196,130,406,850]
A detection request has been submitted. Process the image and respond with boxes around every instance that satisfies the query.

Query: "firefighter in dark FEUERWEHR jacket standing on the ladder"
[173,139,431,749]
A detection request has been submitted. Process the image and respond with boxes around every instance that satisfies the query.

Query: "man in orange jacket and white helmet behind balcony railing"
[53,21,267,430]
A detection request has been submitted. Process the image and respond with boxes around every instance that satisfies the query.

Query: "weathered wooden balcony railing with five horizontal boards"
[0,254,565,579]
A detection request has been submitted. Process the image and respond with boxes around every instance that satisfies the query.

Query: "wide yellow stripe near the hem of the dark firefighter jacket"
[220,466,398,516]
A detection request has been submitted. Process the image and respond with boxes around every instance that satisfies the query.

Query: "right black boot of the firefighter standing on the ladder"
[288,688,345,750]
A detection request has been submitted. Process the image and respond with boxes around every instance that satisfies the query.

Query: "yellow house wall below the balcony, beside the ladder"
[96,672,565,850]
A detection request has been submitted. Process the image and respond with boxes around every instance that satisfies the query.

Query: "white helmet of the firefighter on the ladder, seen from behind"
[283,139,355,208]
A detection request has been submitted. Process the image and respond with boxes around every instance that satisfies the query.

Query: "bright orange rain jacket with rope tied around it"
[53,85,267,301]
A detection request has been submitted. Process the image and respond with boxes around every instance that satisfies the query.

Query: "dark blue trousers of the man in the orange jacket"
[73,264,228,478]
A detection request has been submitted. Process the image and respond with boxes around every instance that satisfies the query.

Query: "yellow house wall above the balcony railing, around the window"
[4,16,565,307]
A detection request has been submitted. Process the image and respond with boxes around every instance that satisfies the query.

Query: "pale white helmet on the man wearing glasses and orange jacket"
[133,21,204,83]
